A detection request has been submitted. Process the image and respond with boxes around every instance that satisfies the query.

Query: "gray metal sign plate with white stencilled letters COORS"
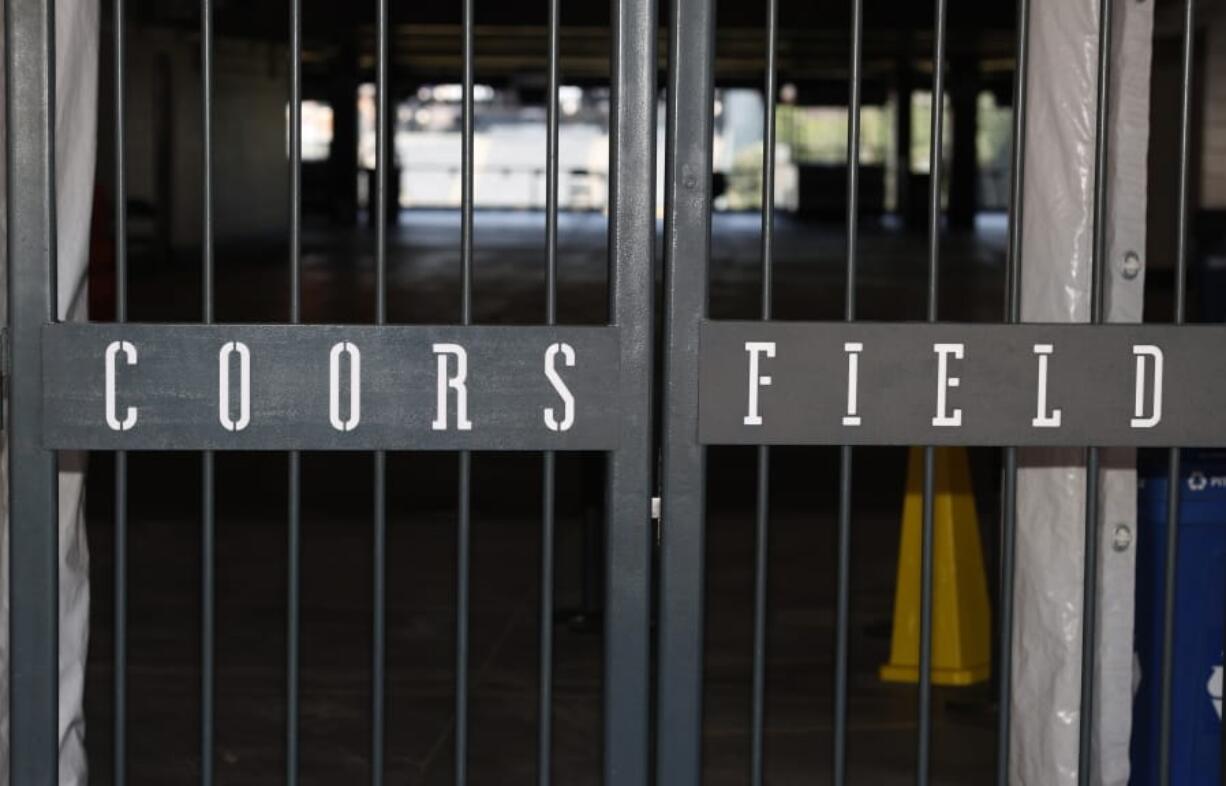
[43,324,620,450]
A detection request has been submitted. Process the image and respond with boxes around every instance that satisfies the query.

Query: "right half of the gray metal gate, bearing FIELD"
[656,0,1201,786]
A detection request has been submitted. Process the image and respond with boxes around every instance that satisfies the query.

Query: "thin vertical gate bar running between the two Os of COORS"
[286,0,303,786]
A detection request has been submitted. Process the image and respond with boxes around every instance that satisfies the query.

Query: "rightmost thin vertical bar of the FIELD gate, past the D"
[1159,0,1197,786]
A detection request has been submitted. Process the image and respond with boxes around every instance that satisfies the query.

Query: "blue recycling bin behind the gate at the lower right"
[1132,450,1226,786]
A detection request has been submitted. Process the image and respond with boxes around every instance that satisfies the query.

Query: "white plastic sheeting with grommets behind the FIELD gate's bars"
[1010,0,1154,786]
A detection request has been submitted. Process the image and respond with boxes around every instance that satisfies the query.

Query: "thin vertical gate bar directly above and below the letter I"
[834,0,864,786]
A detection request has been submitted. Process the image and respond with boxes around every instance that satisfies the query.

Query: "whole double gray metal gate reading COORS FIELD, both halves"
[6,0,1206,786]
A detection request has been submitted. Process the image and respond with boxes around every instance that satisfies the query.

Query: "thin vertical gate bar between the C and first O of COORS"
[200,0,216,786]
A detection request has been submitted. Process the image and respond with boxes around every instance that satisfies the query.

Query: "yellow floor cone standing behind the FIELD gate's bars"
[881,448,992,685]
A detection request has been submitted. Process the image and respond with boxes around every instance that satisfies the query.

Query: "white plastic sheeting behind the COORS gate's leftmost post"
[0,0,98,786]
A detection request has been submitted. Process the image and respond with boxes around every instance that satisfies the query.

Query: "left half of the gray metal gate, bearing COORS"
[6,0,657,785]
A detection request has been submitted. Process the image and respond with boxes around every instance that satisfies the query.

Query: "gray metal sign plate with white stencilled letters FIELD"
[699,321,1226,446]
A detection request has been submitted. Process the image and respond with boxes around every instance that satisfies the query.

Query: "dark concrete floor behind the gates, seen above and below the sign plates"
[87,213,1003,786]
